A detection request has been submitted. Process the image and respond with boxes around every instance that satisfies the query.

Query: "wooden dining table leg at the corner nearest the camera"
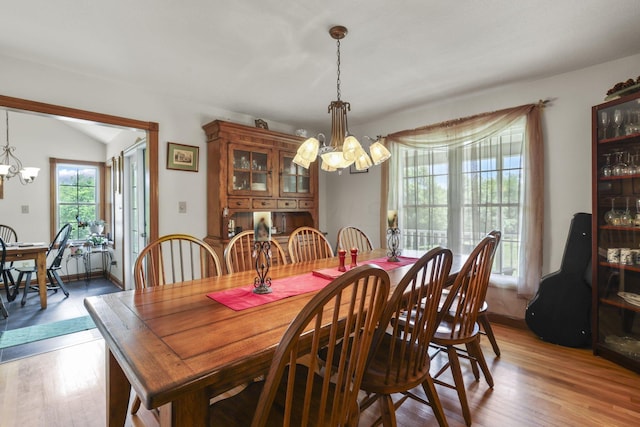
[159,390,209,427]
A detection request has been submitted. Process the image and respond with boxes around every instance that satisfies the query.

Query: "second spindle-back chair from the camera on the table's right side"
[360,247,453,426]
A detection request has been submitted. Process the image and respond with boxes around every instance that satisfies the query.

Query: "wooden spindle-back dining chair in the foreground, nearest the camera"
[210,265,389,427]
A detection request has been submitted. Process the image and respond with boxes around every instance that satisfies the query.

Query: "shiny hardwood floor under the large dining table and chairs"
[0,325,640,427]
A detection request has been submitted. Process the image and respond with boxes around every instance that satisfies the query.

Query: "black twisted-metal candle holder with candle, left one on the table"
[253,212,272,294]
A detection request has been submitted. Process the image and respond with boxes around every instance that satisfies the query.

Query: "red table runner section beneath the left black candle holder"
[207,273,329,311]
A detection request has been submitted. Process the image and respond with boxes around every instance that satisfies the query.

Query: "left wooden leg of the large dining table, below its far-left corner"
[105,344,131,427]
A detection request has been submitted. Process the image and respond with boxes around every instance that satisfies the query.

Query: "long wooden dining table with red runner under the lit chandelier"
[85,249,462,426]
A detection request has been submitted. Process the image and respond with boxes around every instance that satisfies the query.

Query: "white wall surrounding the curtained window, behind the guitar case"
[321,55,640,273]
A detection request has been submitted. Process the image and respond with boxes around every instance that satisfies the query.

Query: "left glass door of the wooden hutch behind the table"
[228,146,272,196]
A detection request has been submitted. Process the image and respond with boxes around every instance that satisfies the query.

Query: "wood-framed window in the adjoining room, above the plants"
[51,159,104,240]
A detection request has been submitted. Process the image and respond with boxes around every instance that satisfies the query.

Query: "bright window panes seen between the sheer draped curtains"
[398,120,524,275]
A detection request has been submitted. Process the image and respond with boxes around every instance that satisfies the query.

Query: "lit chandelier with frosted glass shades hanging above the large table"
[293,26,391,172]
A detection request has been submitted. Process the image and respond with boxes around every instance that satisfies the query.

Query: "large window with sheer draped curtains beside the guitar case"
[381,104,543,295]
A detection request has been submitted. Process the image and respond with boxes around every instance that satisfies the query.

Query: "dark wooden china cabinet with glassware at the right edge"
[592,94,640,372]
